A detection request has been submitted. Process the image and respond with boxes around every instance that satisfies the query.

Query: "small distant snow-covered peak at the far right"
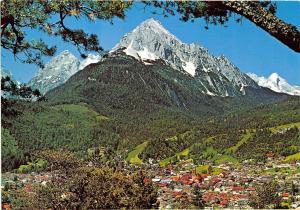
[247,73,300,96]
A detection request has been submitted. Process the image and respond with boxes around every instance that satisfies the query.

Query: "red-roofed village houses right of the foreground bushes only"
[145,158,300,209]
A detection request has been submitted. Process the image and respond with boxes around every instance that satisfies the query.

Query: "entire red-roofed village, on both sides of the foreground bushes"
[2,153,300,209]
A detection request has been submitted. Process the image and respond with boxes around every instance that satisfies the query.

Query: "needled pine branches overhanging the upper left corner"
[0,0,132,67]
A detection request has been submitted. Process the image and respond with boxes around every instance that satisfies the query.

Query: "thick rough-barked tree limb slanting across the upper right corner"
[222,1,300,53]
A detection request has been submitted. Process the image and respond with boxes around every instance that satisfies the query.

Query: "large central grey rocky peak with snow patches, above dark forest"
[110,19,258,96]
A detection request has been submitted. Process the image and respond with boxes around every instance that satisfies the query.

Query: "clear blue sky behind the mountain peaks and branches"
[1,1,300,85]
